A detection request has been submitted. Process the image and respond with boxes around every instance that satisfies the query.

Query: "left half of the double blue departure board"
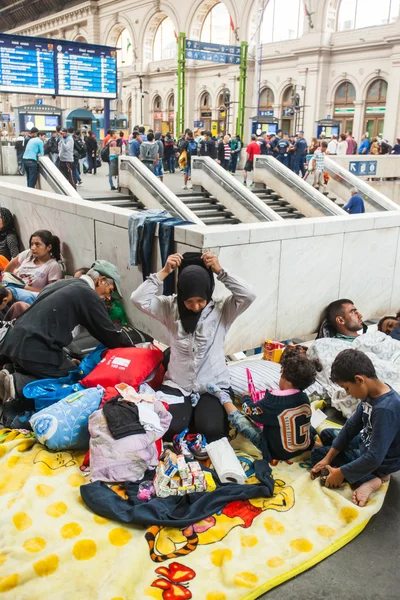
[0,34,56,94]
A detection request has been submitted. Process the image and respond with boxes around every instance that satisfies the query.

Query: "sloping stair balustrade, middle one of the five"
[191,156,283,222]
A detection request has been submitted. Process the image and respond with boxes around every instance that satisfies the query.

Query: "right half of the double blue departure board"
[55,42,117,98]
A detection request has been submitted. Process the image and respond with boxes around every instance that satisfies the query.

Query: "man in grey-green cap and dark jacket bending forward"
[1,260,132,379]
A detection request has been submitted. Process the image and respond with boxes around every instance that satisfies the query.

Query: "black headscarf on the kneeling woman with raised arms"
[178,264,215,333]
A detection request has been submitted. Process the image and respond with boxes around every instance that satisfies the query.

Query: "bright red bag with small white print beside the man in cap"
[81,346,164,391]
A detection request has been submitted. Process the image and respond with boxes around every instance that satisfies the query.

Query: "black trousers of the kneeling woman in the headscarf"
[161,386,229,443]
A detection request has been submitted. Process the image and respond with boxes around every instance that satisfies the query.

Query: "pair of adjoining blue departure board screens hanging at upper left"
[0,33,117,98]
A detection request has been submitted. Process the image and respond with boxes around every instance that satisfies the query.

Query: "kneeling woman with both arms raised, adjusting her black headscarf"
[131,252,255,451]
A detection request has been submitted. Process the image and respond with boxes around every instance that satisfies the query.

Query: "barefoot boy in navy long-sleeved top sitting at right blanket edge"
[311,350,400,506]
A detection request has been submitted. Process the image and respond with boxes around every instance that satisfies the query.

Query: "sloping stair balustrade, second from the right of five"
[254,155,348,217]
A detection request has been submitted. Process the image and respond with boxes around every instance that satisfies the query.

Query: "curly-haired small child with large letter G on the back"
[219,347,317,460]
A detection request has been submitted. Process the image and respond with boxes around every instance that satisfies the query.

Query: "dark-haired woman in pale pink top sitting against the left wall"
[5,230,62,292]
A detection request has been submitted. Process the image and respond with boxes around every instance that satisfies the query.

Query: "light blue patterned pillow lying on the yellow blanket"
[29,386,104,451]
